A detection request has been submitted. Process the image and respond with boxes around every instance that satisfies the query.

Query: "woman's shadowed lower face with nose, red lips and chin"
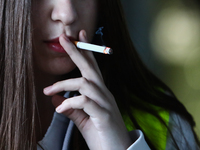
[32,0,97,75]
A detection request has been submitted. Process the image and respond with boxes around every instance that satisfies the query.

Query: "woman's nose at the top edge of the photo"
[51,0,77,25]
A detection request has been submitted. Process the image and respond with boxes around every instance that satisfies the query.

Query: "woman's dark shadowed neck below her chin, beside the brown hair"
[35,71,66,141]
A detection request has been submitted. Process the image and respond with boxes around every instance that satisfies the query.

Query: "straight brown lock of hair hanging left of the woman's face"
[0,0,36,150]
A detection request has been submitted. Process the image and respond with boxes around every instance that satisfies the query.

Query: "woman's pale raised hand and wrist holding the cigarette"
[44,30,131,150]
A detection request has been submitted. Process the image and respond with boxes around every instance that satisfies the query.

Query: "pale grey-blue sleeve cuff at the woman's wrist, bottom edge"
[127,130,150,150]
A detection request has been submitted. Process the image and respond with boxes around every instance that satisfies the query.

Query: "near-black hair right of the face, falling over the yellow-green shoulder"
[96,0,199,149]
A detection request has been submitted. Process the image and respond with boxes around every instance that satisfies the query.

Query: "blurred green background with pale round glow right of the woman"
[122,0,200,137]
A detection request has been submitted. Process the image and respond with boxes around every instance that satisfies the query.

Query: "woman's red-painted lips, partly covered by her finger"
[44,37,66,53]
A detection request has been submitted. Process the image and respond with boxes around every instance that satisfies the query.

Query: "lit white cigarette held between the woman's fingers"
[73,41,113,54]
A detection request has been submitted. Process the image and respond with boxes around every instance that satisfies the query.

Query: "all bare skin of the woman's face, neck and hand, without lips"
[33,0,132,150]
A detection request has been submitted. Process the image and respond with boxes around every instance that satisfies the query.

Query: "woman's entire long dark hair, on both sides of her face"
[0,0,198,150]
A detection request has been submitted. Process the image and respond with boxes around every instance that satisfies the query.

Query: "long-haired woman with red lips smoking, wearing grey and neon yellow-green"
[0,0,199,150]
